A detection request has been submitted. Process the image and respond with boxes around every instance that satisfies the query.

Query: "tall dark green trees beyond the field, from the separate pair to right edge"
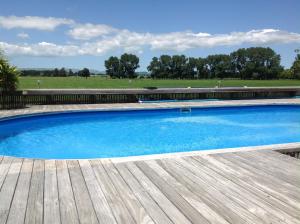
[105,47,300,79]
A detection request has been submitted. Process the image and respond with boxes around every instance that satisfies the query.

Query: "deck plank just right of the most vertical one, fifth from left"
[56,160,79,224]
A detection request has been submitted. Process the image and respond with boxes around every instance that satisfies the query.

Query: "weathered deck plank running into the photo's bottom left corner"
[0,159,23,224]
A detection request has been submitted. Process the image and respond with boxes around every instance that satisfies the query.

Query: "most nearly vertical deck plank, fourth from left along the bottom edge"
[44,160,60,224]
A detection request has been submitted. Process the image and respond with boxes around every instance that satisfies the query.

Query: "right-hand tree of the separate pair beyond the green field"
[120,53,140,78]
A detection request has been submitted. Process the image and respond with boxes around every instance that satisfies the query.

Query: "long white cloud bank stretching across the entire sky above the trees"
[0,21,300,56]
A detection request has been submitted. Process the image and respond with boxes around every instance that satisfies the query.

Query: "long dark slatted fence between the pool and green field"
[0,87,300,109]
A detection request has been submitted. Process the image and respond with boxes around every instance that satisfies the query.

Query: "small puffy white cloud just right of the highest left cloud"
[68,23,118,40]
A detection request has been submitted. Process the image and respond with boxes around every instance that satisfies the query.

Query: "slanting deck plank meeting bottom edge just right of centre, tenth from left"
[114,163,172,224]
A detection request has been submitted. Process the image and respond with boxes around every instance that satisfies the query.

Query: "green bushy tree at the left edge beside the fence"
[0,54,20,92]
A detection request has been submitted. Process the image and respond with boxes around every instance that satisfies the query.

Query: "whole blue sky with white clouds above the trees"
[0,0,300,71]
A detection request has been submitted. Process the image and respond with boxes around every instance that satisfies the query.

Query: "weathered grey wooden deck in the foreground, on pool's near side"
[0,150,300,224]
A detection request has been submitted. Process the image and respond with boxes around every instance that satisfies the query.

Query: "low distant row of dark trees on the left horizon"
[20,68,94,78]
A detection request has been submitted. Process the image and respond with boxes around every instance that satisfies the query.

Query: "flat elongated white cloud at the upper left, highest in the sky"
[0,16,74,31]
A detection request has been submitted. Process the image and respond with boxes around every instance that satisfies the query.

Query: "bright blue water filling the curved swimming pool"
[0,106,300,159]
